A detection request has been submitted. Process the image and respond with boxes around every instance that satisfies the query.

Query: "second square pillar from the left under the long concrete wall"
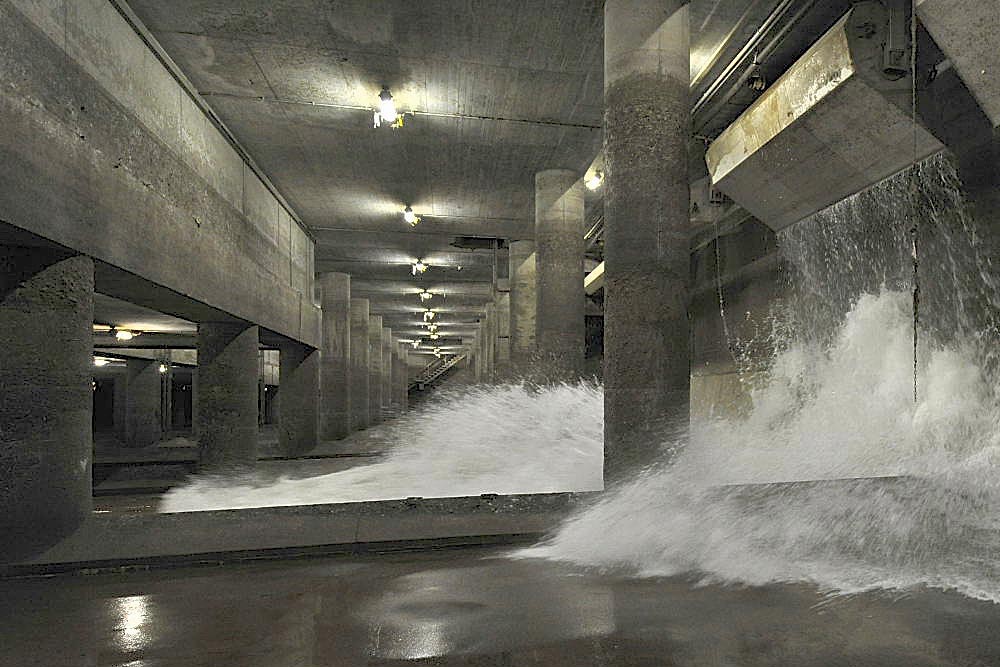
[194,322,260,469]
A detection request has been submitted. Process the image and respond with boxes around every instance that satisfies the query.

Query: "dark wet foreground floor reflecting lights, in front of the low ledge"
[0,549,1000,667]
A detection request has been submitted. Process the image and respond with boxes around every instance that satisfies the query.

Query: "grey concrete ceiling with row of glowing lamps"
[119,0,842,354]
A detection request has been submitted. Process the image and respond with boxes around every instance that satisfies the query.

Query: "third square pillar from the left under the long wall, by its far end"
[278,341,320,456]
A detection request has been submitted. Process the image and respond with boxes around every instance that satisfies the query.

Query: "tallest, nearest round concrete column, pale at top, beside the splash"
[604,0,691,482]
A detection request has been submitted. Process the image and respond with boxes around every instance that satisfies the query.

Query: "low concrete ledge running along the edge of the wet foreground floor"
[0,493,594,578]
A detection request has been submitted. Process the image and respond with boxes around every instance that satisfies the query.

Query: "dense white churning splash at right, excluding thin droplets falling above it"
[521,291,1000,601]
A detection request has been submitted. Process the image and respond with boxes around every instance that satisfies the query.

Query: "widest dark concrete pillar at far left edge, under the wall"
[0,245,94,561]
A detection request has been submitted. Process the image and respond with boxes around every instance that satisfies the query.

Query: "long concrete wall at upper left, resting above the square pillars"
[0,0,319,345]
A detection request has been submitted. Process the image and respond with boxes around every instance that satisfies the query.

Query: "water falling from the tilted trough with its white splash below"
[518,157,1000,602]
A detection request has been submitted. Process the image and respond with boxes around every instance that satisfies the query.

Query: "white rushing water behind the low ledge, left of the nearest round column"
[160,383,604,512]
